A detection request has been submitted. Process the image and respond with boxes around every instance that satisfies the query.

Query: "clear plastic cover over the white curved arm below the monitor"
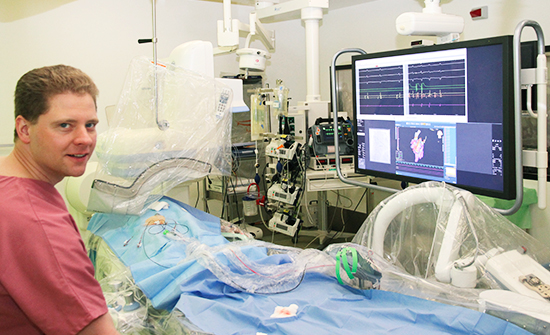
[352,182,550,309]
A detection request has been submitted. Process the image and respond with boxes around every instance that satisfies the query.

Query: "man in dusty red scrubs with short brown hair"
[0,65,118,335]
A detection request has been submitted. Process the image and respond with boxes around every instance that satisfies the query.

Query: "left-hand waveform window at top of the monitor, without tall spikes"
[359,65,404,115]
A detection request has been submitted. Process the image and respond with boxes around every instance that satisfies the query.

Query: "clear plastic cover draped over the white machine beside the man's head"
[88,57,232,214]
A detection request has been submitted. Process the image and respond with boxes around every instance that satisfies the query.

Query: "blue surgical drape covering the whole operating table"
[88,198,528,335]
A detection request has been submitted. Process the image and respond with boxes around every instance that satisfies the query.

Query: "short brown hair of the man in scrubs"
[14,65,99,139]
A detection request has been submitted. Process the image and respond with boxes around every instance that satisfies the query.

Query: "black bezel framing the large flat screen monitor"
[352,36,516,200]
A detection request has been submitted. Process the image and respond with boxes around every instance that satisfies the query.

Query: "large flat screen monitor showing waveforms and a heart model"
[352,36,516,199]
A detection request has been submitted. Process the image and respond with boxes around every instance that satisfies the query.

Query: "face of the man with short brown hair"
[29,93,98,184]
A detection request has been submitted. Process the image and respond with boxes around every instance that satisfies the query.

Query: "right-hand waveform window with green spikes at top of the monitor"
[408,59,466,115]
